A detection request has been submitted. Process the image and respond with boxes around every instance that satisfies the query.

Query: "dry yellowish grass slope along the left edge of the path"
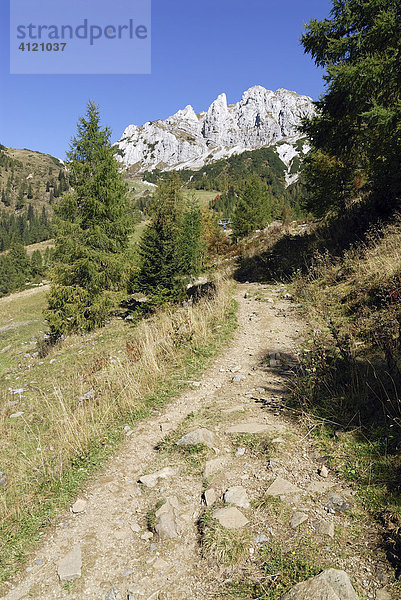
[0,281,236,580]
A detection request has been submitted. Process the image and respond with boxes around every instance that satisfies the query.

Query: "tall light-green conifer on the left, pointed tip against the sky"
[46,102,130,338]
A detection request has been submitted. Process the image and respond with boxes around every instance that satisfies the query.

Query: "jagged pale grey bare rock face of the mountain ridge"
[117,85,314,172]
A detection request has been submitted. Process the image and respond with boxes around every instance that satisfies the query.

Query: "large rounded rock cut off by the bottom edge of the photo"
[281,569,358,600]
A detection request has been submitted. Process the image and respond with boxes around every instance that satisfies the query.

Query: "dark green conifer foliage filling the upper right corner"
[302,0,401,215]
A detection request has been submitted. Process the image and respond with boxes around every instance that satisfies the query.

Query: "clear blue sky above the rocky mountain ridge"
[0,0,331,158]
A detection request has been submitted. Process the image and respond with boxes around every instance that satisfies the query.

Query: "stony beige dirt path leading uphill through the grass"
[4,284,391,600]
